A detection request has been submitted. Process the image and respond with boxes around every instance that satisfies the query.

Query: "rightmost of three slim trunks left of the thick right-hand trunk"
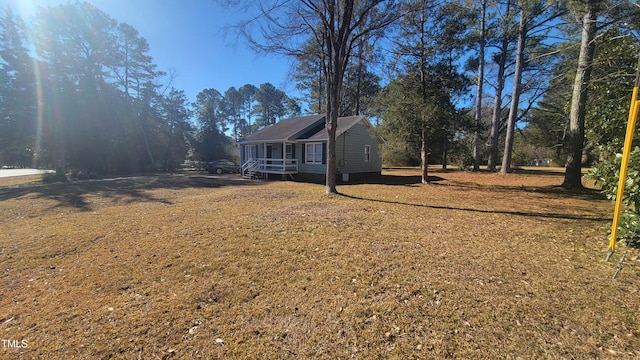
[500,9,527,174]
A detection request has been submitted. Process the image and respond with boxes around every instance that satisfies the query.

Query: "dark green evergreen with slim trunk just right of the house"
[383,0,468,183]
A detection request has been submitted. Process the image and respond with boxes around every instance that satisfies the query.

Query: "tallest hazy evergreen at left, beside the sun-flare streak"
[35,2,116,173]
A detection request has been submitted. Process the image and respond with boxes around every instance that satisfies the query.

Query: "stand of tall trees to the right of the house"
[288,0,640,188]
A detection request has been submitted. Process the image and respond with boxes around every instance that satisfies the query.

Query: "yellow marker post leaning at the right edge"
[605,57,640,261]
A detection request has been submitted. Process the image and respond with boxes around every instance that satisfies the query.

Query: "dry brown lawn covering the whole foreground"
[0,169,640,359]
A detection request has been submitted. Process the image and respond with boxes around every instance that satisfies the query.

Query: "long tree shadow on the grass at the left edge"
[0,175,259,211]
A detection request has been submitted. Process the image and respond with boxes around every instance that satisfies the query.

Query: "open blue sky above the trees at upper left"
[0,0,296,101]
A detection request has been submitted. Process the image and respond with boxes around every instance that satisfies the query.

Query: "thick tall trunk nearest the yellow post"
[562,1,597,189]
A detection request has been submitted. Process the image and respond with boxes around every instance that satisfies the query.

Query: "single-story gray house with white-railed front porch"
[238,115,382,183]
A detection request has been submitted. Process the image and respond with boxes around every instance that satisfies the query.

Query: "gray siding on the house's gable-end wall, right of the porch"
[336,124,382,174]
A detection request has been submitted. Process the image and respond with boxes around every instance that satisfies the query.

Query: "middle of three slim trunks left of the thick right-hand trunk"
[487,1,511,171]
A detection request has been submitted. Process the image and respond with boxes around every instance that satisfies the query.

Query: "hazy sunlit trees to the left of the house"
[0,2,300,176]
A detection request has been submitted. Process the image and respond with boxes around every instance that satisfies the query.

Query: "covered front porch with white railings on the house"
[240,142,298,178]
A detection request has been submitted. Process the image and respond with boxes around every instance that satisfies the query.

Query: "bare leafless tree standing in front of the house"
[232,0,401,194]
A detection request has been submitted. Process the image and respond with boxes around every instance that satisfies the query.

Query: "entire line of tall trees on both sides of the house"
[0,0,640,193]
